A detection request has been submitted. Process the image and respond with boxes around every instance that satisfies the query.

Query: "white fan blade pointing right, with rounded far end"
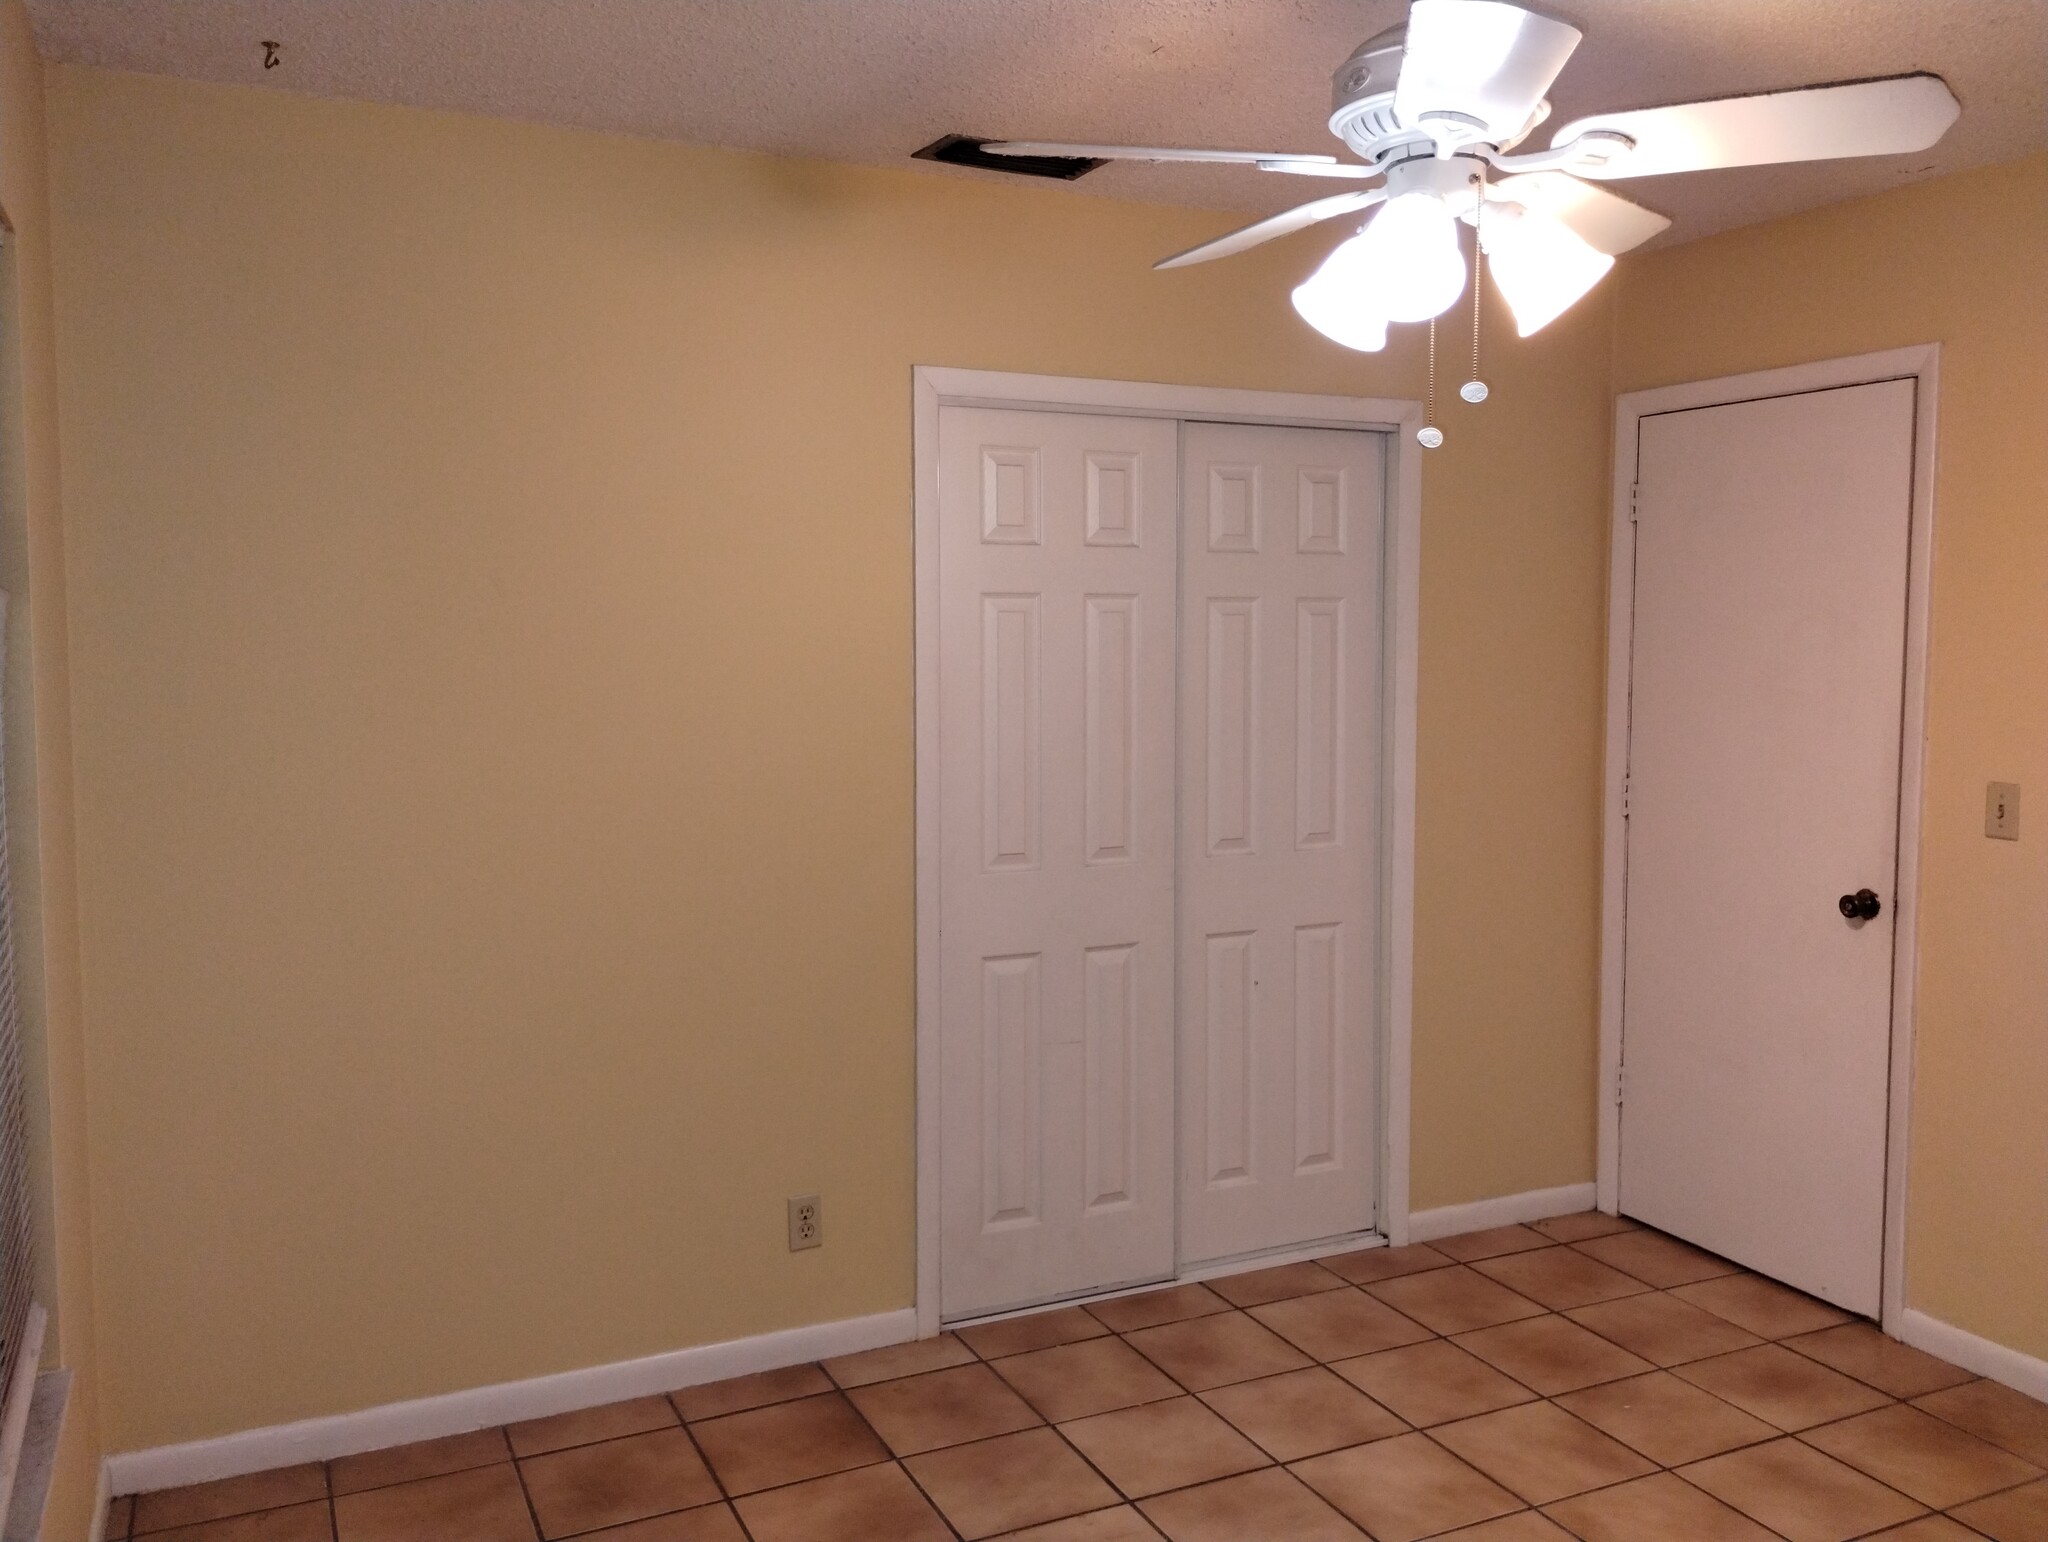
[1550,76,1962,180]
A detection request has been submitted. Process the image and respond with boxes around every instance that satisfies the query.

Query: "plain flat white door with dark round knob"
[1620,381,1915,1315]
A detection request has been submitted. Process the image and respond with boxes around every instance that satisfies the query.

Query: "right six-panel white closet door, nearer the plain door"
[1180,424,1386,1261]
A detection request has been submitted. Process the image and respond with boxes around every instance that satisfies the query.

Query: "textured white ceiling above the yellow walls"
[29,0,2048,242]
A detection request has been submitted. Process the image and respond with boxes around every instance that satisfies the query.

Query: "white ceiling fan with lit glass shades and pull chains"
[983,0,1962,444]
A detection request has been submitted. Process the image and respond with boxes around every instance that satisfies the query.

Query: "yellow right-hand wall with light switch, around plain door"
[1616,156,2048,1358]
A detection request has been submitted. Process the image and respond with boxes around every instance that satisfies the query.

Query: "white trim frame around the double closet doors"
[911,365,1423,1337]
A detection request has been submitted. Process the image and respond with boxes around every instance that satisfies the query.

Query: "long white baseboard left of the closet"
[100,1307,918,1511]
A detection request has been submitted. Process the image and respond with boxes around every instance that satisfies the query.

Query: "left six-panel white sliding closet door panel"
[938,408,1178,1317]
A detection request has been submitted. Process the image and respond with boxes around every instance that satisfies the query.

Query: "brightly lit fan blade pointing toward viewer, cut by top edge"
[1395,0,1581,143]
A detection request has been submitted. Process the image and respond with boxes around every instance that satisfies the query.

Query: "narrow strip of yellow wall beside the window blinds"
[0,0,100,1538]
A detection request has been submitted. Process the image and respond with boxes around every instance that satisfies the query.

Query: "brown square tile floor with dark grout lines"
[106,1214,2048,1542]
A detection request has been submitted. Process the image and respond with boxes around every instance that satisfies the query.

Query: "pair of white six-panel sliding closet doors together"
[936,408,1384,1319]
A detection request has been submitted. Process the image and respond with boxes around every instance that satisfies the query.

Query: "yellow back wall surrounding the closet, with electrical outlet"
[51,68,1612,1450]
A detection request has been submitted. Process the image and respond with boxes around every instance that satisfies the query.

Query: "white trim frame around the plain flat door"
[1595,342,1942,1335]
